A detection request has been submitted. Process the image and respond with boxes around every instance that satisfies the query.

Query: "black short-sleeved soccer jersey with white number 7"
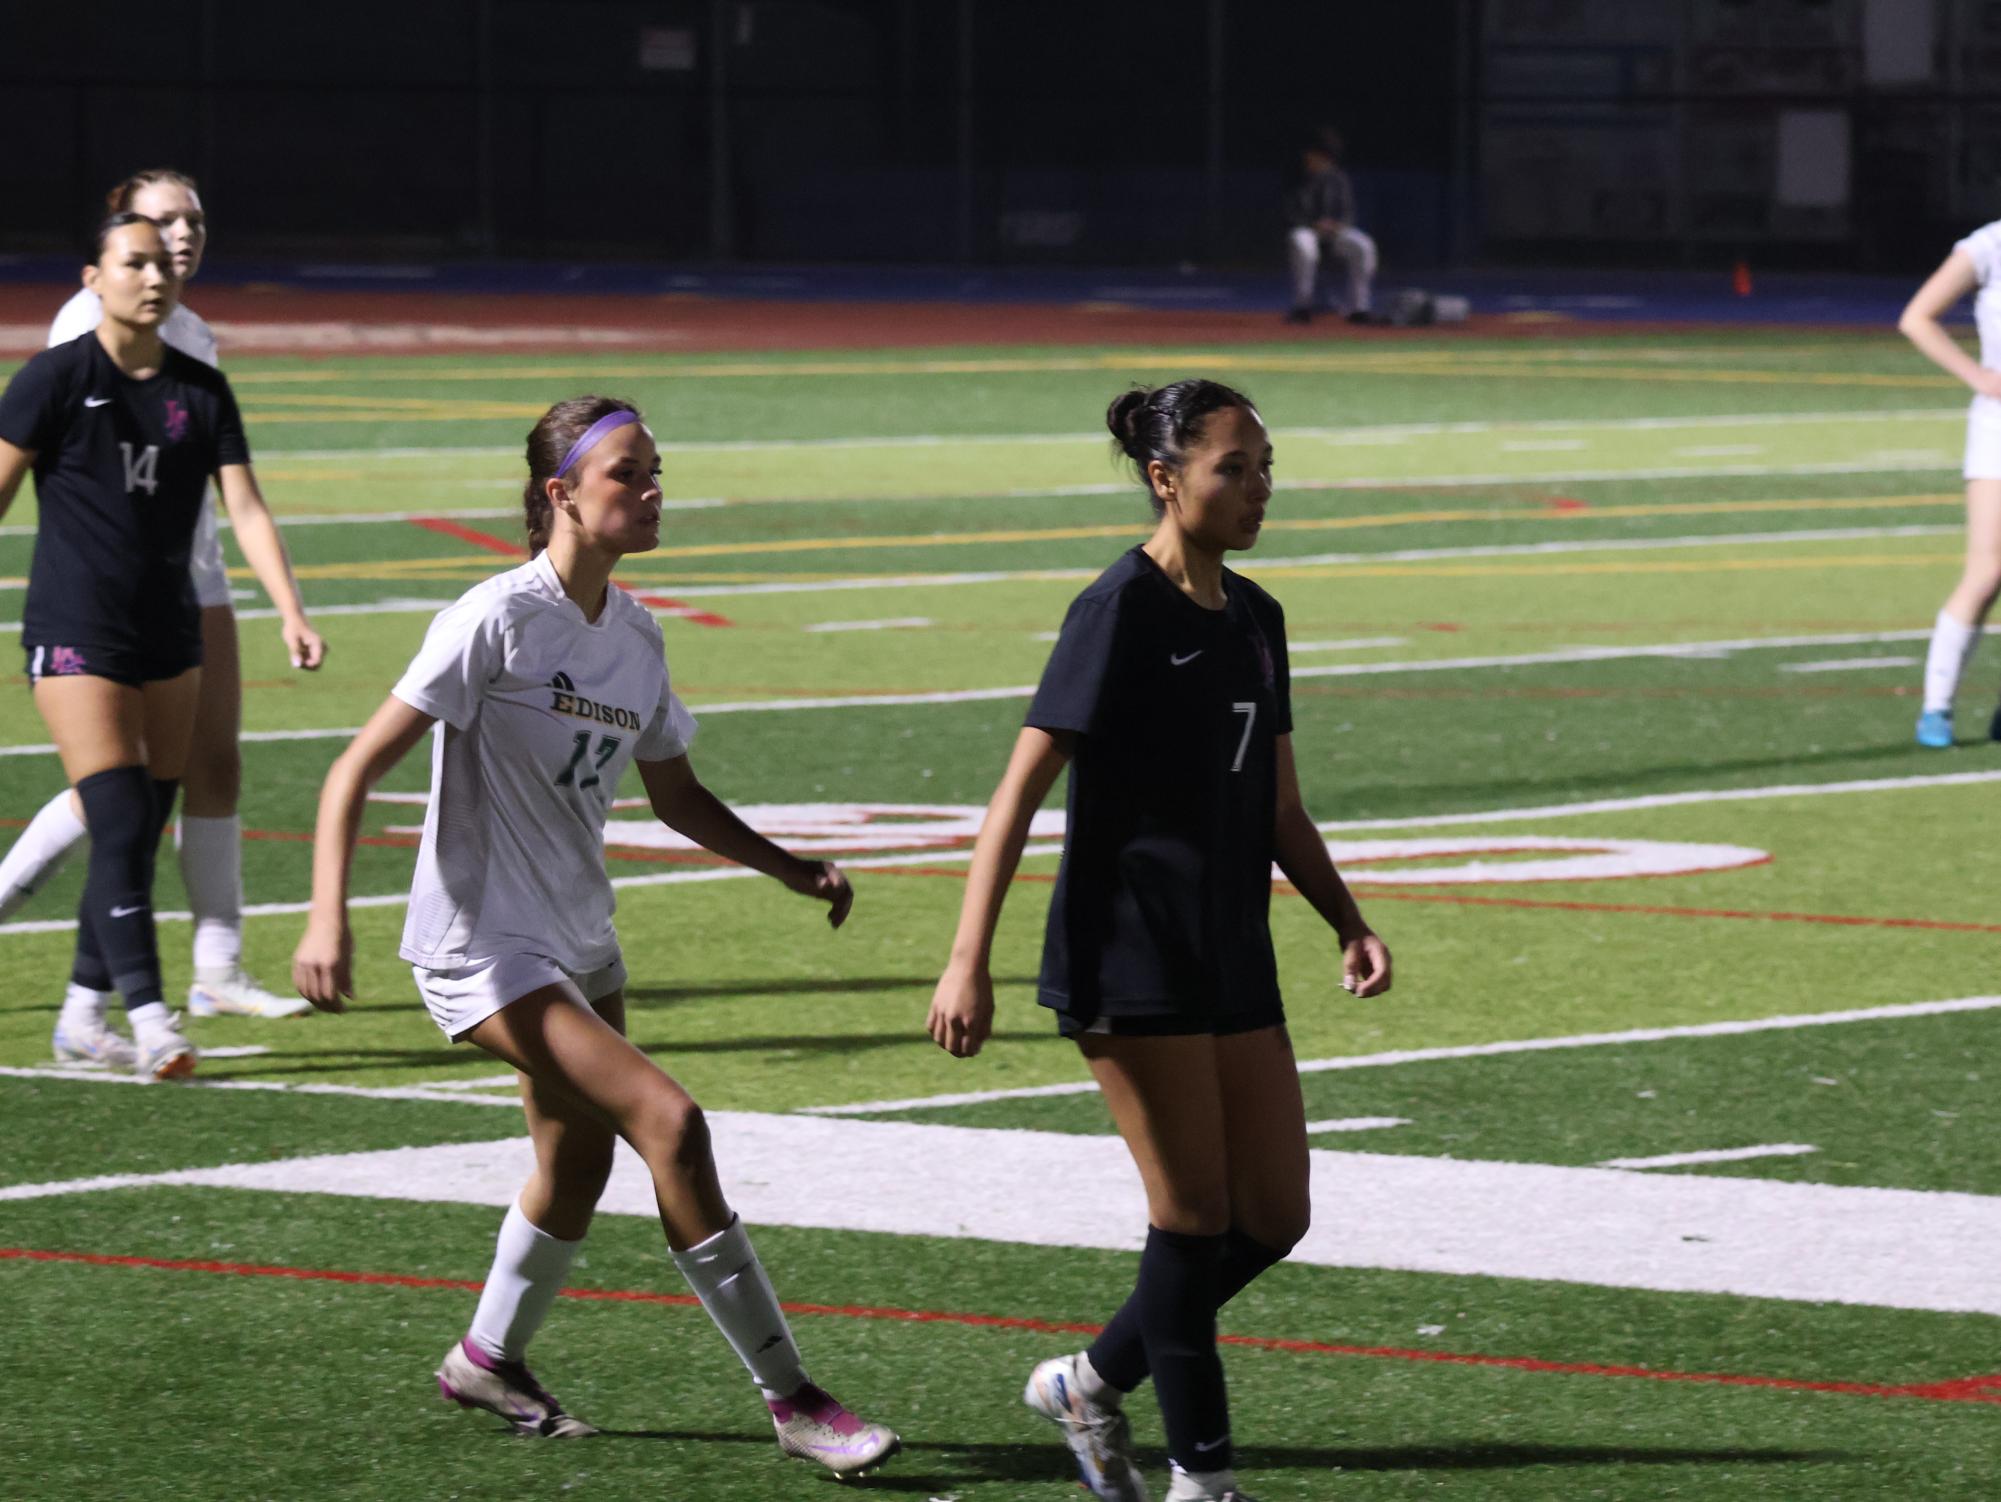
[1029,548,1293,1022]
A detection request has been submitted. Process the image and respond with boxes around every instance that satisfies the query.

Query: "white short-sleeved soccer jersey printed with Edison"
[394,554,694,974]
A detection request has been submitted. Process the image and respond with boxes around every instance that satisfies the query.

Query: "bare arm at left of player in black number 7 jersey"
[924,726,1077,1058]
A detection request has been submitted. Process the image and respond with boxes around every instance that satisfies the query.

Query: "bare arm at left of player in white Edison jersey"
[292,694,436,1012]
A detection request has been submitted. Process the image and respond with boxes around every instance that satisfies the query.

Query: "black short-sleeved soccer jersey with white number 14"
[0,334,250,662]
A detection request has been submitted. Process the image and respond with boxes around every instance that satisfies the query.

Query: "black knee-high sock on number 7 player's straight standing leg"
[1133,1226,1231,1470]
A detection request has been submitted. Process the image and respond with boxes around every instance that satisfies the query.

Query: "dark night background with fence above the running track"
[0,0,2001,272]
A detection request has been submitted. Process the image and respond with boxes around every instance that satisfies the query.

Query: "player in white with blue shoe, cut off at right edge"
[1897,220,2001,750]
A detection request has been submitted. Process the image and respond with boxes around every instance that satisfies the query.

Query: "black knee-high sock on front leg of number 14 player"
[72,766,178,1012]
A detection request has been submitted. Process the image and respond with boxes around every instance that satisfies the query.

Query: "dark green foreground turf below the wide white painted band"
[11,1190,1991,1502]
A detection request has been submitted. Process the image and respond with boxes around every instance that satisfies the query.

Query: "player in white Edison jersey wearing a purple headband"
[292,396,900,1474]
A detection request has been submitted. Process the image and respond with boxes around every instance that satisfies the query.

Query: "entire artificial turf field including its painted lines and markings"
[0,330,2001,1502]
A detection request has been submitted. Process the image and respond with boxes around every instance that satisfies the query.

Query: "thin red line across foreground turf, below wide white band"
[0,1246,2001,1404]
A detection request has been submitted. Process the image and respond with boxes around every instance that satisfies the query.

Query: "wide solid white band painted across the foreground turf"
[11,1112,2001,1314]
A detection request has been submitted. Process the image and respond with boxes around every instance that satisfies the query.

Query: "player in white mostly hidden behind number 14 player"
[0,168,326,1068]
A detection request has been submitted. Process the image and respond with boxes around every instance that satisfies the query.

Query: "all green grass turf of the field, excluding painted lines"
[0,334,2001,1502]
